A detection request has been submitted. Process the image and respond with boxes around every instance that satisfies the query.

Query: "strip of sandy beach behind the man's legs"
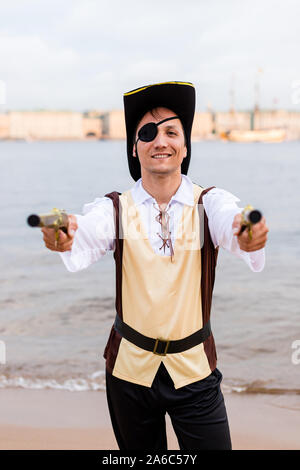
[0,389,300,450]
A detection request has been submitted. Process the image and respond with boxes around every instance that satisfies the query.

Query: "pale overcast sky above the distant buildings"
[0,0,300,111]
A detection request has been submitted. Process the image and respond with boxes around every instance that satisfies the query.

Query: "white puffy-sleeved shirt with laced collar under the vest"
[59,175,265,272]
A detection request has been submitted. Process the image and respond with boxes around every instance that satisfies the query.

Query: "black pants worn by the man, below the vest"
[106,363,231,451]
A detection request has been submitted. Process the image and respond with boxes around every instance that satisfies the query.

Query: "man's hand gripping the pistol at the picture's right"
[232,214,269,251]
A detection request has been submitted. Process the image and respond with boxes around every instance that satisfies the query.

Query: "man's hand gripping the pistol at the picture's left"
[41,215,78,252]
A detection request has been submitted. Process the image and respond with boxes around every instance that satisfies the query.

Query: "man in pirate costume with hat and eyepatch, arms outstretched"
[42,82,268,451]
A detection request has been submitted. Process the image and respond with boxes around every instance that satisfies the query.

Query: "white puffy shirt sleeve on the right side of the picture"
[203,188,265,272]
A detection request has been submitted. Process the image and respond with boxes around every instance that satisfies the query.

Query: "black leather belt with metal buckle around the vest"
[114,314,211,356]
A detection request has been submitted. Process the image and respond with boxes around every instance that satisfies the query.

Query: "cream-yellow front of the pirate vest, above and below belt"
[105,184,211,388]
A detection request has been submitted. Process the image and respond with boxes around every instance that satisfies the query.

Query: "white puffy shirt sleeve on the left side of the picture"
[59,197,115,272]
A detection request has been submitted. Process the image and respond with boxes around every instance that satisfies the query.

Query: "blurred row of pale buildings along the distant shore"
[0,110,300,141]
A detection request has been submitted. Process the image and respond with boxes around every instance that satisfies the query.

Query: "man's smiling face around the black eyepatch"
[133,108,187,177]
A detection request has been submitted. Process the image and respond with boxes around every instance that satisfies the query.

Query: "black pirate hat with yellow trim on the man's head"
[124,82,196,181]
